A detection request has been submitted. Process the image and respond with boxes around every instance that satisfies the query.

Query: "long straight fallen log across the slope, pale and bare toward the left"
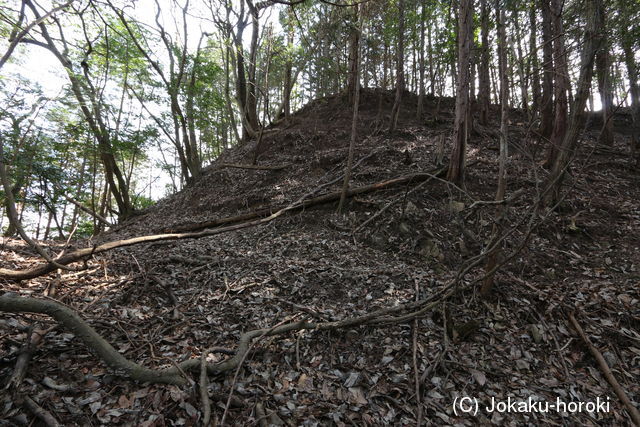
[0,169,446,280]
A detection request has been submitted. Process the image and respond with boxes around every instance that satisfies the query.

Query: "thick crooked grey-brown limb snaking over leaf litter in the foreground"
[0,288,450,385]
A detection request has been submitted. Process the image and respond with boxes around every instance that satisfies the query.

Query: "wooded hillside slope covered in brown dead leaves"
[0,90,640,426]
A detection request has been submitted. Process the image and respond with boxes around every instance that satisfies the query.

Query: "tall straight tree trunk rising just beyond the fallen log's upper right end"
[447,0,473,185]
